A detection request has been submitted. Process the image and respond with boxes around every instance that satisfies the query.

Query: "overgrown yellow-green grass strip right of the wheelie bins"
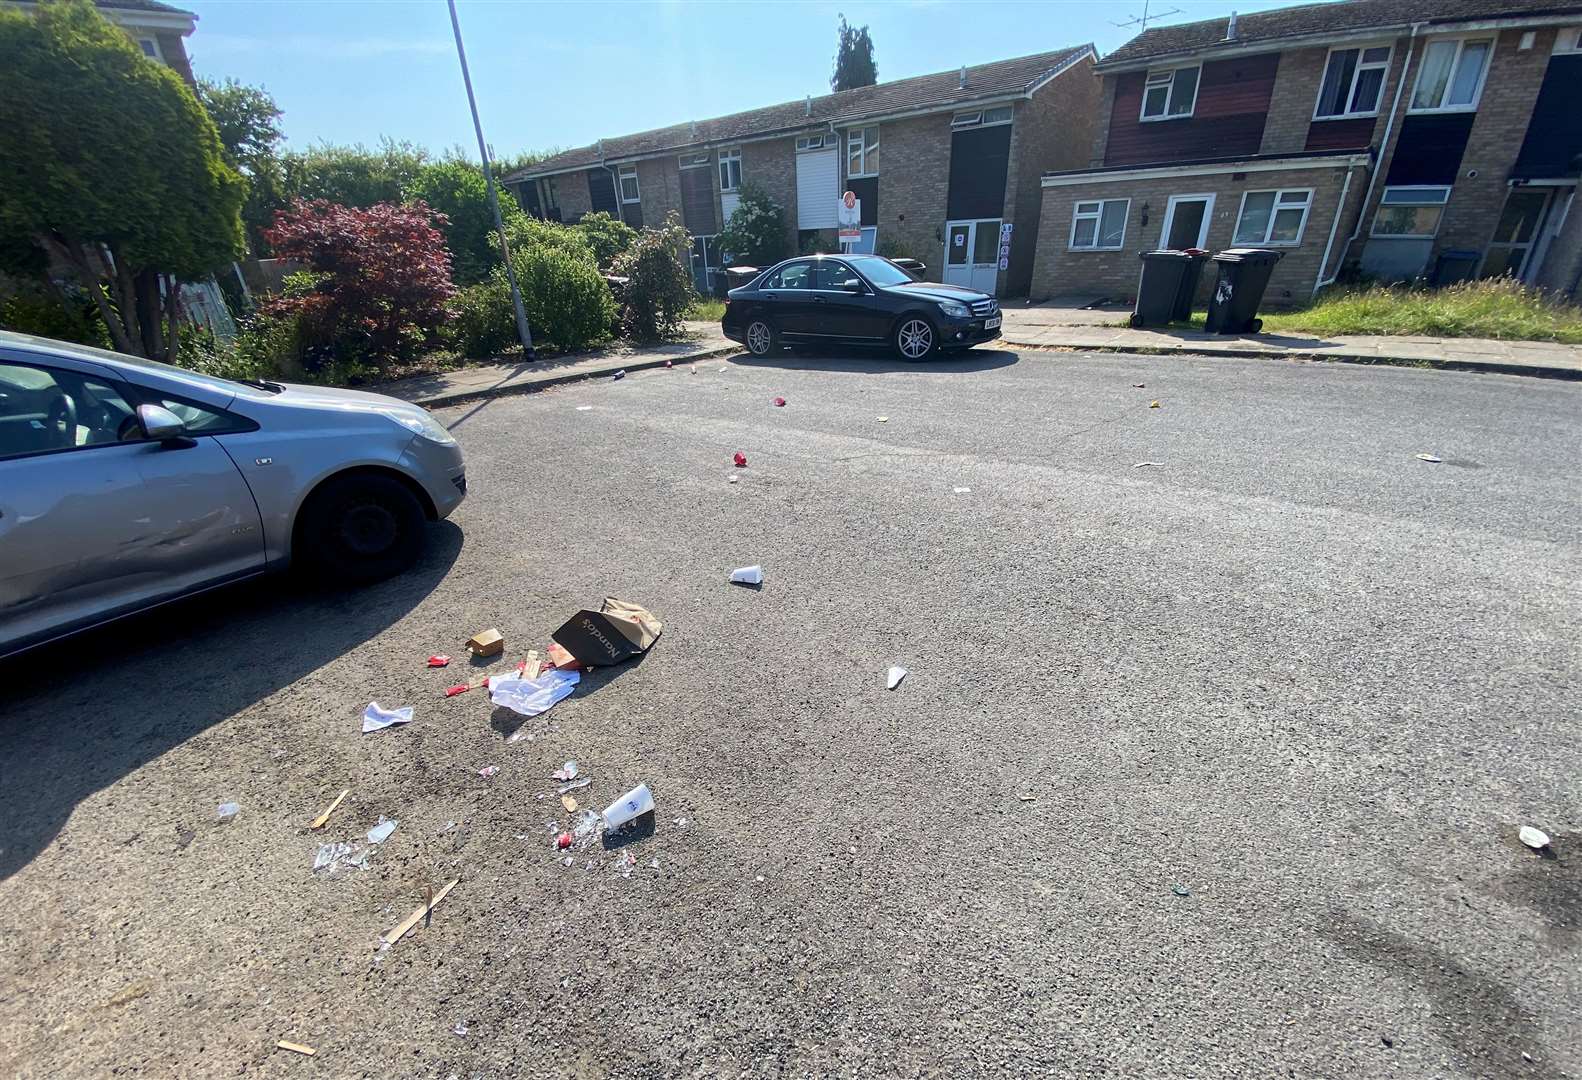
[1259,278,1582,345]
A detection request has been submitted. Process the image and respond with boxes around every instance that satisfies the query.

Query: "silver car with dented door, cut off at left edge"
[0,332,467,656]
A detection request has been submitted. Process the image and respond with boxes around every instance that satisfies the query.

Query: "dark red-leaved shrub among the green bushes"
[266,199,456,368]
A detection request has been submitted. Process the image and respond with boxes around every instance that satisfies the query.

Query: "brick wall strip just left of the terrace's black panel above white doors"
[878,112,951,281]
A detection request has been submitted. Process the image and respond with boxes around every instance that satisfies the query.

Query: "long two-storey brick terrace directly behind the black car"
[505,46,1099,294]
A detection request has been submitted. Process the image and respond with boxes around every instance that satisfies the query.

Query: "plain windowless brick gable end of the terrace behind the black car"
[1000,60,1103,296]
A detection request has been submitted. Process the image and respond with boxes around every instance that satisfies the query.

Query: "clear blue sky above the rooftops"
[176,0,1309,157]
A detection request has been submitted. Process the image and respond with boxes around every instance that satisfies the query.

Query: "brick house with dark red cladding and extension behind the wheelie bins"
[1031,0,1582,305]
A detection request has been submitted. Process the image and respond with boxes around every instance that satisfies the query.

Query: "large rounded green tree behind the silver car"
[0,0,244,361]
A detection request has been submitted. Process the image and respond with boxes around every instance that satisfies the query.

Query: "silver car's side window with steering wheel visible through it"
[0,362,139,460]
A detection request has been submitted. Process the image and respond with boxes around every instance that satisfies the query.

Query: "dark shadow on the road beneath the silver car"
[0,522,462,881]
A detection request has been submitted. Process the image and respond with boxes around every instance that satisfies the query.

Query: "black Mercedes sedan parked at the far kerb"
[720,255,1000,361]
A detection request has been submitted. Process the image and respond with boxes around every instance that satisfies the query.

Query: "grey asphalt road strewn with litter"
[0,351,1582,1080]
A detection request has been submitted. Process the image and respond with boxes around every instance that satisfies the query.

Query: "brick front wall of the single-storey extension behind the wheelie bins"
[1031,168,1365,307]
